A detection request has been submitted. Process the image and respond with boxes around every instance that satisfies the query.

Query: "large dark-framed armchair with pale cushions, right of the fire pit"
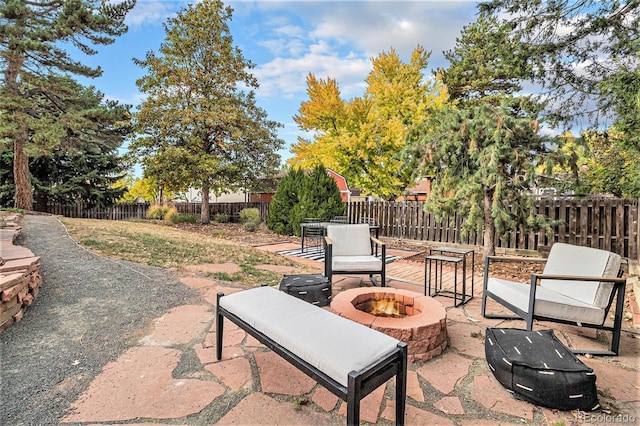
[482,243,626,355]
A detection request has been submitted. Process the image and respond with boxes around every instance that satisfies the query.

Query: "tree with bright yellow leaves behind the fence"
[289,46,448,199]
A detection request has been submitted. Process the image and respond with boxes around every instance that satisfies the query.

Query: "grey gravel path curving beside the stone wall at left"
[0,215,198,425]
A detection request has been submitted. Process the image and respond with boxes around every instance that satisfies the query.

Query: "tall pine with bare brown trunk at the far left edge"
[0,0,135,210]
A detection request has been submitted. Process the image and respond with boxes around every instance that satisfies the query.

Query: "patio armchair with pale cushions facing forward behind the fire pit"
[324,224,387,287]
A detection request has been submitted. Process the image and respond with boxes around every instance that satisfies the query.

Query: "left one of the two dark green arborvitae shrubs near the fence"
[267,168,305,235]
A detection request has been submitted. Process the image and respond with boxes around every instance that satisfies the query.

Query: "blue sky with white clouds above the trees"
[78,0,477,168]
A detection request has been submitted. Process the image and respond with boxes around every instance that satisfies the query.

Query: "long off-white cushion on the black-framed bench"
[220,286,400,387]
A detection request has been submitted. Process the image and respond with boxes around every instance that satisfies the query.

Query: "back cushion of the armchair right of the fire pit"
[540,243,622,308]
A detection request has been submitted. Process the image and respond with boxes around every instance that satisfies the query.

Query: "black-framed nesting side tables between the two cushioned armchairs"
[424,247,475,307]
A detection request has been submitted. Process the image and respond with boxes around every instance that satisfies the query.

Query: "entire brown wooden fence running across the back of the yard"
[40,197,640,260]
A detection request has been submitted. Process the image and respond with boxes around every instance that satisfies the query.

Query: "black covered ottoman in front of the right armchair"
[485,328,600,411]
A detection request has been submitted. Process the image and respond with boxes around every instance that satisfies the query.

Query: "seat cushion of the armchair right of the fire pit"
[487,278,606,325]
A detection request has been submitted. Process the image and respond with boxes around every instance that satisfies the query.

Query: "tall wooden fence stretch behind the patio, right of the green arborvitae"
[347,197,640,259]
